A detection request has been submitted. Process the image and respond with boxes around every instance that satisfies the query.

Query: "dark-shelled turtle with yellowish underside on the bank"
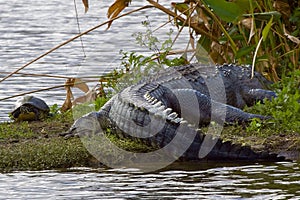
[10,95,50,121]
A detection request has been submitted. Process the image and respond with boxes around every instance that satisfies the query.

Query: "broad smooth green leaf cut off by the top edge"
[204,0,249,22]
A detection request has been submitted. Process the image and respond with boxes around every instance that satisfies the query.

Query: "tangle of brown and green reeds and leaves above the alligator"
[97,0,300,81]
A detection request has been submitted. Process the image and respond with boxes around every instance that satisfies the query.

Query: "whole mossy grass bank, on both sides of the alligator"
[0,108,300,172]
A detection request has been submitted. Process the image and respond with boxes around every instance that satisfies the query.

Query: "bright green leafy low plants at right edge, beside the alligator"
[247,70,300,133]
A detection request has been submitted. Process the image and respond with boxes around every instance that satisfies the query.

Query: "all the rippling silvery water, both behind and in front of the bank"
[0,0,300,199]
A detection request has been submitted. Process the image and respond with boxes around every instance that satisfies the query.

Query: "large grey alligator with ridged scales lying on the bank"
[62,64,284,161]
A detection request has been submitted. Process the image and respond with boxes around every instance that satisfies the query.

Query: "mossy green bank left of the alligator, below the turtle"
[0,111,149,172]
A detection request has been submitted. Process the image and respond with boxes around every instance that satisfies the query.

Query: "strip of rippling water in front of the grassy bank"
[0,162,300,200]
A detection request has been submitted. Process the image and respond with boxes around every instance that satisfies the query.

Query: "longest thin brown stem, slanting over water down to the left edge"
[0,5,153,83]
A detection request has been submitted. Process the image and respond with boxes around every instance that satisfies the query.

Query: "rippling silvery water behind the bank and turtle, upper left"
[0,0,187,121]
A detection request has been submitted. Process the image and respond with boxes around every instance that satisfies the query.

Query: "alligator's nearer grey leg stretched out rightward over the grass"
[172,89,269,126]
